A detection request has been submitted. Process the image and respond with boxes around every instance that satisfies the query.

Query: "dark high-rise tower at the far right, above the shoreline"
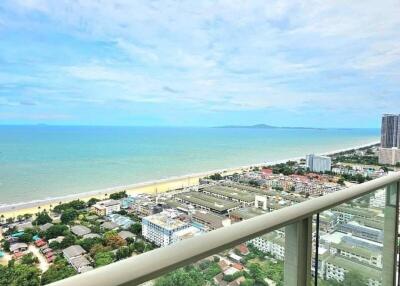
[381,114,400,148]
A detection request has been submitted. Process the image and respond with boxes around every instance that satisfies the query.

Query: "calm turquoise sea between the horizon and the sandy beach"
[0,126,379,204]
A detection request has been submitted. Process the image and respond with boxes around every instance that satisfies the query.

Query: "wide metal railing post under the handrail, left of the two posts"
[283,217,312,286]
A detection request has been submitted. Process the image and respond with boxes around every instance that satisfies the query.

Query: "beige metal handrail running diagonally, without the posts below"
[51,172,400,286]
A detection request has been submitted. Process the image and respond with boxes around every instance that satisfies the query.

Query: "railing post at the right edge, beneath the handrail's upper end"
[382,182,399,286]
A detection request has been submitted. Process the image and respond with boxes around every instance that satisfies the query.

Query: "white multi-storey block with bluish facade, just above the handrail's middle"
[142,211,190,246]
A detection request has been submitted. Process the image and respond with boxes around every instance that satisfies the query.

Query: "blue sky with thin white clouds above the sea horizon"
[0,0,400,128]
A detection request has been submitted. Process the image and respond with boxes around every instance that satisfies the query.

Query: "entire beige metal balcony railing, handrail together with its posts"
[52,172,400,286]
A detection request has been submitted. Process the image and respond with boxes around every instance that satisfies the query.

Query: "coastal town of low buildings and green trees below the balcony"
[0,140,399,286]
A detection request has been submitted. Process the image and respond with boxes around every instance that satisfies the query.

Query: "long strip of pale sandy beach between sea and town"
[0,141,379,218]
